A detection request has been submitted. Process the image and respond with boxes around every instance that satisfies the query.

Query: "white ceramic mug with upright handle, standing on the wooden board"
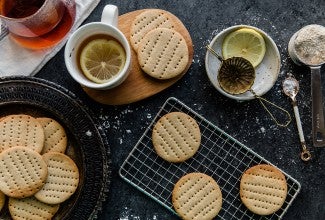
[64,5,131,90]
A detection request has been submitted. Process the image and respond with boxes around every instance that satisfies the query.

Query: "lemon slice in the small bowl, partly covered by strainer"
[222,28,266,67]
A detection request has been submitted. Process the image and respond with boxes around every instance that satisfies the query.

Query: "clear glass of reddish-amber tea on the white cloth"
[0,0,75,49]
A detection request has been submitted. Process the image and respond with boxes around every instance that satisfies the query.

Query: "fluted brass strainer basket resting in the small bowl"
[218,57,255,95]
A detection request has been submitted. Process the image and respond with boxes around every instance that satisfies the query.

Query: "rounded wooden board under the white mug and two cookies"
[83,9,194,105]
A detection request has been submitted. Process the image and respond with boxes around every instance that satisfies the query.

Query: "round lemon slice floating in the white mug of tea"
[80,39,126,83]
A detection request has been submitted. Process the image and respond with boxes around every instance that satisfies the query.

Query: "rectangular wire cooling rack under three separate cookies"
[119,98,301,220]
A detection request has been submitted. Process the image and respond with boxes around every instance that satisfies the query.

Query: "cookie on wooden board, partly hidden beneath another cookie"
[130,9,174,51]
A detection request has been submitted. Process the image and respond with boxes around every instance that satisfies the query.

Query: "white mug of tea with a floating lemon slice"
[64,5,131,90]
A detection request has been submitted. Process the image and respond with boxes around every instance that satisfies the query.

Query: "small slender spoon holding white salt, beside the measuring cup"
[282,74,311,161]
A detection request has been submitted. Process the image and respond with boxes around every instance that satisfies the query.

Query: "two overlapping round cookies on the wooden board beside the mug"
[130,9,189,80]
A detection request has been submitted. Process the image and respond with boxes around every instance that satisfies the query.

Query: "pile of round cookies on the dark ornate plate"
[0,114,79,219]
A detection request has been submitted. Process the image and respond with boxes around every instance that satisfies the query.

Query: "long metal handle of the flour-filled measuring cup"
[310,66,325,147]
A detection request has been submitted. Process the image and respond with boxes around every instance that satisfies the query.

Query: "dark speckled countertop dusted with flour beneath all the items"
[36,0,325,220]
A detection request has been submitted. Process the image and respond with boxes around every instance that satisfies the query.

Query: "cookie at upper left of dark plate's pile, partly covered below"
[0,114,44,153]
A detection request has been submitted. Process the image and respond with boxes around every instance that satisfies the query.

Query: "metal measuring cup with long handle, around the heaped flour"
[288,25,325,147]
